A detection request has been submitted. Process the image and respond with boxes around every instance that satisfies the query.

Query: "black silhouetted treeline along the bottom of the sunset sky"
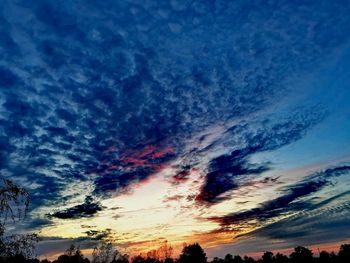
[0,243,350,263]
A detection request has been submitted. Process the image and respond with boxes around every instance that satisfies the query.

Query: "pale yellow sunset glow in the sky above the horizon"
[41,171,227,252]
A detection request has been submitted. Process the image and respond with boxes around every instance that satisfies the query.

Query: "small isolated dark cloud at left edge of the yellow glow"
[50,196,103,219]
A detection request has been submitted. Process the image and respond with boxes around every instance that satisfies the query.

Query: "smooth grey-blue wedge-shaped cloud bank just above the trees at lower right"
[235,191,350,253]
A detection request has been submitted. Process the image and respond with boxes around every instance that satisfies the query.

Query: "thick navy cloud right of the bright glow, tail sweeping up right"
[197,111,321,204]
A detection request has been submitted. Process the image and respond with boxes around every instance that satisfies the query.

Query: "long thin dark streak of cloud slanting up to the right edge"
[209,165,350,236]
